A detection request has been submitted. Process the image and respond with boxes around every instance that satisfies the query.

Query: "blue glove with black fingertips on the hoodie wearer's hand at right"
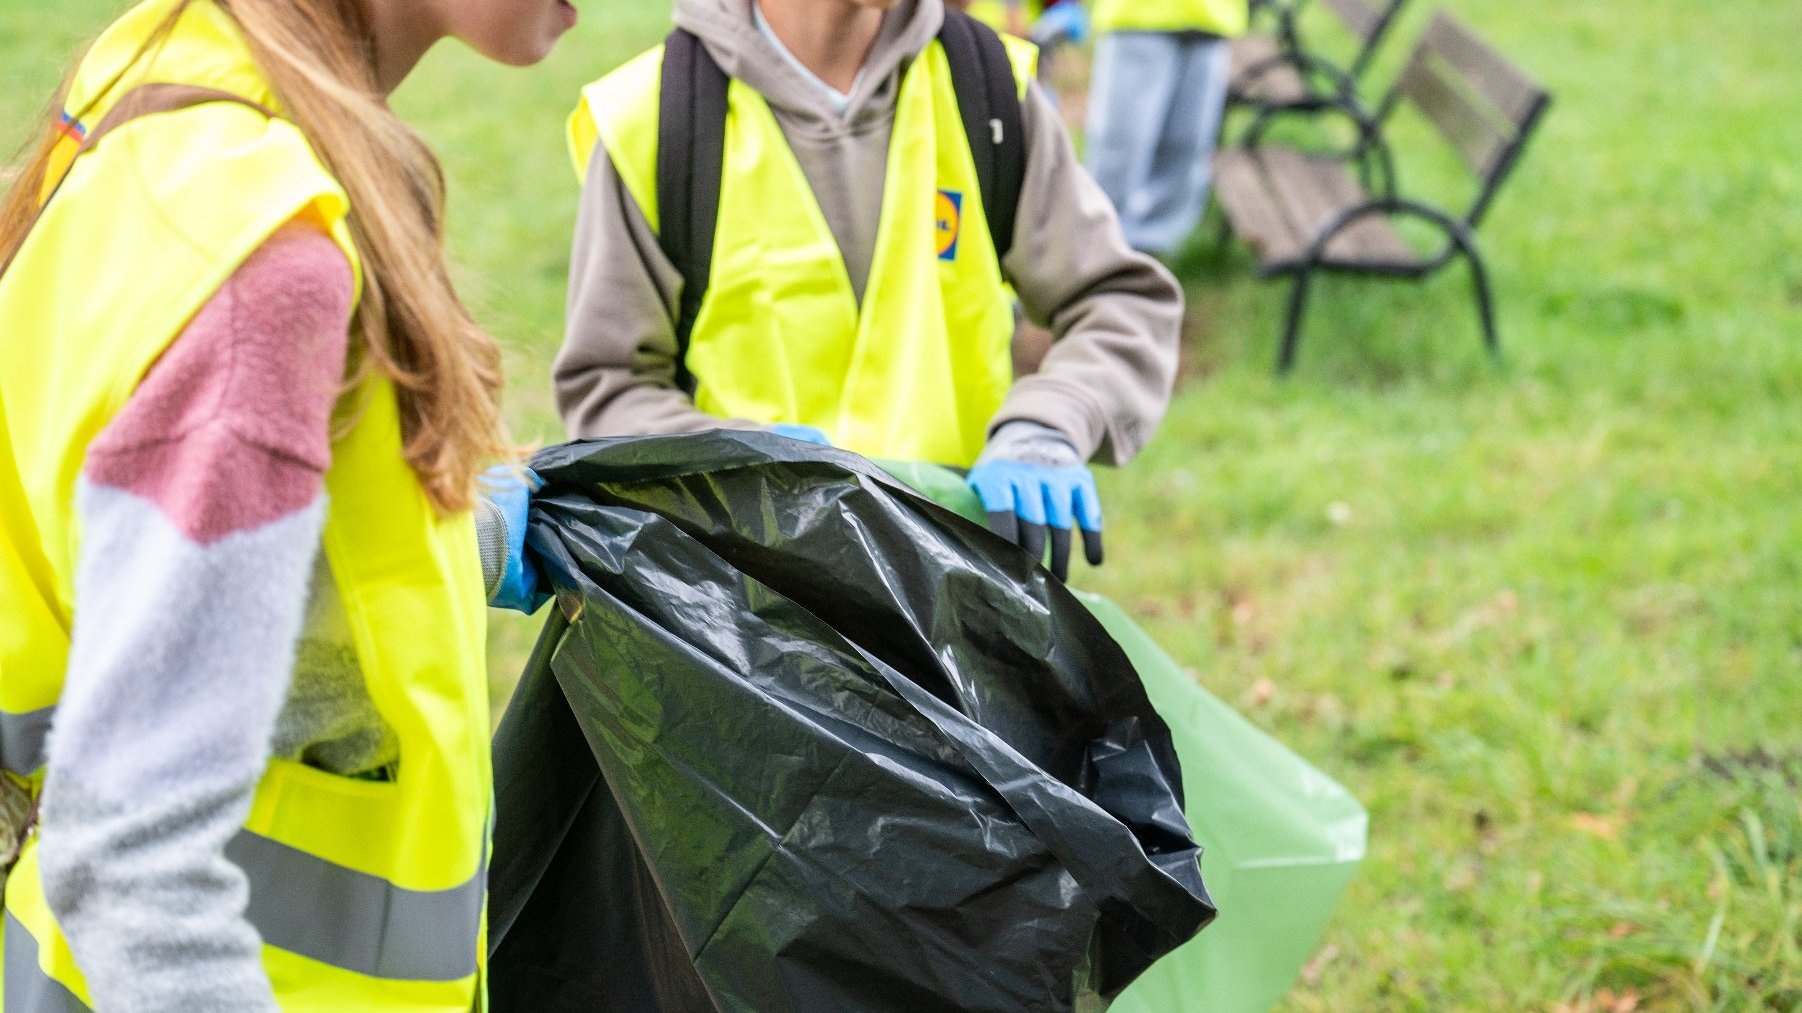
[968,422,1101,580]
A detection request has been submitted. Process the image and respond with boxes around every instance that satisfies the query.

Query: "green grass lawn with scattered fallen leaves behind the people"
[0,0,1802,1013]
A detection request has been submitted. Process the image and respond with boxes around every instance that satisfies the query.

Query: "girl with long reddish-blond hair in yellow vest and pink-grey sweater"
[0,0,558,1013]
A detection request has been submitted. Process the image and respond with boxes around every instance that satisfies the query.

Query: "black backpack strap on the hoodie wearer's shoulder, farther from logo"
[658,29,730,393]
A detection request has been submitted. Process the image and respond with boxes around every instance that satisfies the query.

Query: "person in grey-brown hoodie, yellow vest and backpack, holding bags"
[555,0,1182,571]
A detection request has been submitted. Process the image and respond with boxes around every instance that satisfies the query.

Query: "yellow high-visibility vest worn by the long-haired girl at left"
[0,0,492,1013]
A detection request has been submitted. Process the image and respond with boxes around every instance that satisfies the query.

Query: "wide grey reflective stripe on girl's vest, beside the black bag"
[227,831,488,980]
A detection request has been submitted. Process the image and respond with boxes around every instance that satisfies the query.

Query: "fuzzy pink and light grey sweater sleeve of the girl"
[40,225,353,1011]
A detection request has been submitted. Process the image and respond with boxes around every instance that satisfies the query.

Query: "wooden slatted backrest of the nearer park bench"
[1380,11,1552,224]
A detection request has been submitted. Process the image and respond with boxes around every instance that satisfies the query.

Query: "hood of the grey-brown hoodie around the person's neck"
[676,0,944,133]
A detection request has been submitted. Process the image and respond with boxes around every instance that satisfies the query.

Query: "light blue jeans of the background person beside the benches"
[1087,32,1231,256]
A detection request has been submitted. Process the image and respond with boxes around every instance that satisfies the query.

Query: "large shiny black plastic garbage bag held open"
[490,433,1215,1013]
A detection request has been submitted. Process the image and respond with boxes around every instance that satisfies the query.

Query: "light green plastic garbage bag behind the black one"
[883,463,1370,1013]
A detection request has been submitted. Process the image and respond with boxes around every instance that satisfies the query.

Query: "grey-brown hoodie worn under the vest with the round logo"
[553,0,1182,465]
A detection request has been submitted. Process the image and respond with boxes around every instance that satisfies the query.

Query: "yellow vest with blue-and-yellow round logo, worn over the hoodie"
[569,40,1036,465]
